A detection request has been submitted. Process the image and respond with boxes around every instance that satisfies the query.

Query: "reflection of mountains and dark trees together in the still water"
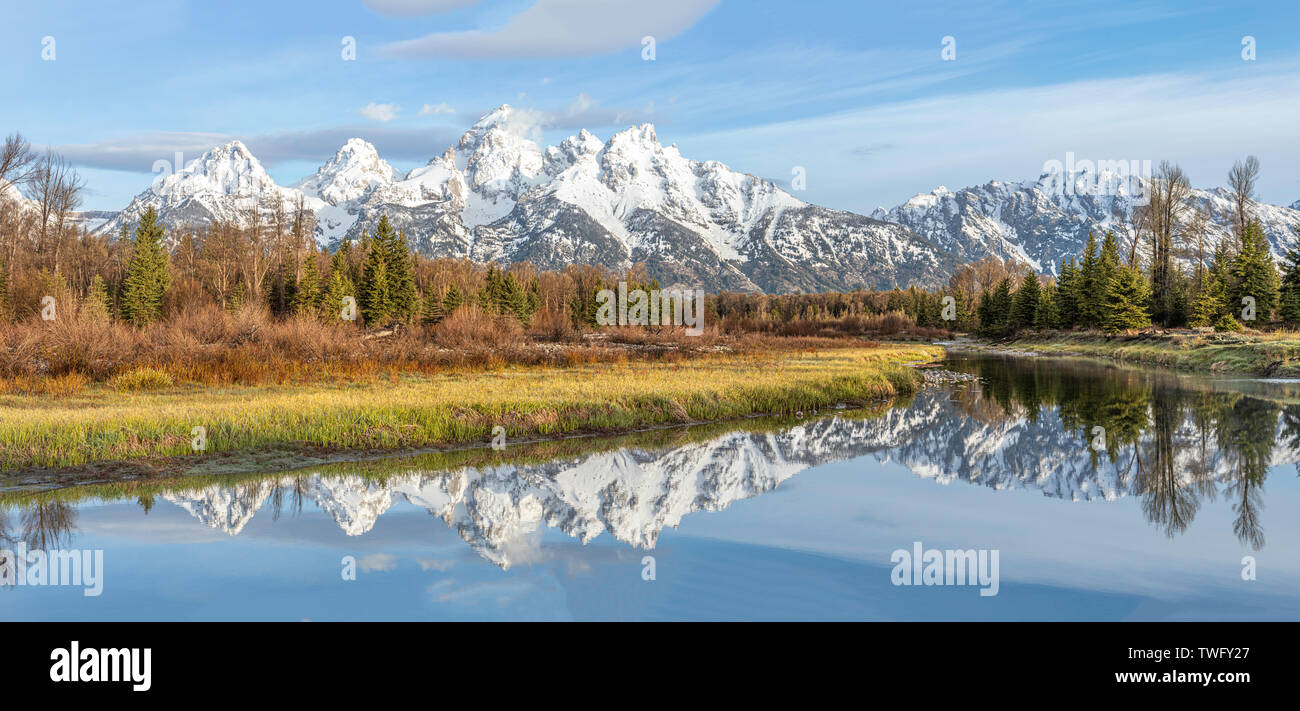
[10,357,1279,568]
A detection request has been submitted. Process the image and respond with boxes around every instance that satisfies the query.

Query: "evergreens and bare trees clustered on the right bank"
[972,156,1300,337]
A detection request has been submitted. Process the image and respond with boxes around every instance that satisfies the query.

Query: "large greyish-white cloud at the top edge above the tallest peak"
[386,0,718,58]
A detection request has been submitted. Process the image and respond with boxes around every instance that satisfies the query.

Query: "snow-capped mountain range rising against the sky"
[73,105,1300,292]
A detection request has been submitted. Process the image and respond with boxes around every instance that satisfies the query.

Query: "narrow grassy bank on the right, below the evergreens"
[975,331,1300,377]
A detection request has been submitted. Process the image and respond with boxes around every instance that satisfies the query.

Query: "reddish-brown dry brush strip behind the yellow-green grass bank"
[0,304,935,396]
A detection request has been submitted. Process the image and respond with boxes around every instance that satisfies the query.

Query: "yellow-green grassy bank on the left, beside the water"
[0,344,943,473]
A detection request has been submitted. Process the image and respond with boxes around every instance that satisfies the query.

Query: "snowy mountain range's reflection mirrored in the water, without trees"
[163,390,1284,568]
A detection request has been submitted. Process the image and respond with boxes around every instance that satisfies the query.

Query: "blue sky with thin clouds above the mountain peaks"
[0,0,1300,212]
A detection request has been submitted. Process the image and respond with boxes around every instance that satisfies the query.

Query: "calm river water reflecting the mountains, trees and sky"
[0,357,1300,620]
